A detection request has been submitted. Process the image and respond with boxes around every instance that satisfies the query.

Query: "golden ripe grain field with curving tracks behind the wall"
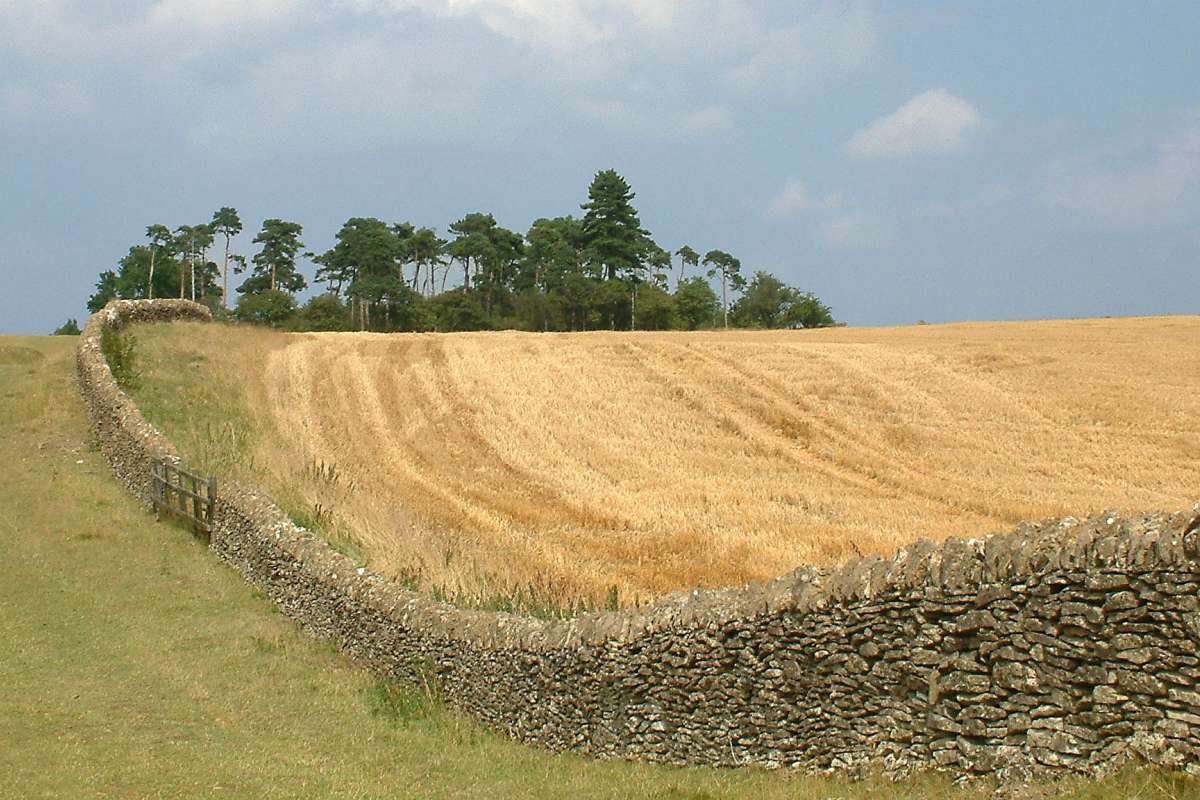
[136,317,1200,602]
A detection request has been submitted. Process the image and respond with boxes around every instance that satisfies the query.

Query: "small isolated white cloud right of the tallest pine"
[846,89,984,158]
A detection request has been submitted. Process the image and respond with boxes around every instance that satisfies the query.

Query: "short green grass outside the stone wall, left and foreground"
[0,337,1200,800]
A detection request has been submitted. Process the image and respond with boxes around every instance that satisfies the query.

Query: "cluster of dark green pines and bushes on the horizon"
[88,169,834,331]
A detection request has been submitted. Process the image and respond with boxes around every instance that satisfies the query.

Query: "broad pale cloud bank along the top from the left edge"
[0,0,876,146]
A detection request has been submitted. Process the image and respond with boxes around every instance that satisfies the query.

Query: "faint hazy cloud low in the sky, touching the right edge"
[1042,108,1200,227]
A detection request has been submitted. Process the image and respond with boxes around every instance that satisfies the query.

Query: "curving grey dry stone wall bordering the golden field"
[78,301,1200,777]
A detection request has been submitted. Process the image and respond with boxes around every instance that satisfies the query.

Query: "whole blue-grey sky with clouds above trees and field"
[0,0,1200,333]
